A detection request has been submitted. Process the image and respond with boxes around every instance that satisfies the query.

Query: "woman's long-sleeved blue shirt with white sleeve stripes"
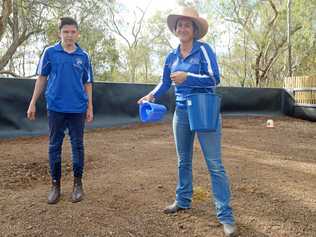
[151,40,220,107]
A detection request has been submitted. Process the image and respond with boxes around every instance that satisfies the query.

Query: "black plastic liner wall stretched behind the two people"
[0,78,316,138]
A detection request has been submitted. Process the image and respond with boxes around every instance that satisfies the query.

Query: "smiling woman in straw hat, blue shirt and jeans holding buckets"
[138,7,236,236]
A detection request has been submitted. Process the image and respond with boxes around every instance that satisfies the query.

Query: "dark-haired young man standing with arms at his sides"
[27,17,93,204]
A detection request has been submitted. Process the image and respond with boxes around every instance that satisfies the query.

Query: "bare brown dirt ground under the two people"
[0,117,316,237]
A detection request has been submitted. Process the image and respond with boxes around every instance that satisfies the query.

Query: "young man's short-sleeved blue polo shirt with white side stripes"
[37,42,93,113]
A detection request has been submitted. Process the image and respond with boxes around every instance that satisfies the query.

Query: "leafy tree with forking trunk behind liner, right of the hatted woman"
[218,0,302,87]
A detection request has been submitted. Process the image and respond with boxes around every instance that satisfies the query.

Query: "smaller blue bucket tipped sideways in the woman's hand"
[139,101,167,123]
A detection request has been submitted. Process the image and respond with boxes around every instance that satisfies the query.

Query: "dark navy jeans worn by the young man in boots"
[48,110,85,180]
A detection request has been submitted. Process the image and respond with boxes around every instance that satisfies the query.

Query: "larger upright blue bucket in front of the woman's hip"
[187,93,221,132]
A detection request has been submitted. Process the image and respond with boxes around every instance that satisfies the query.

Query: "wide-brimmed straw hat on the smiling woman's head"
[167,7,208,39]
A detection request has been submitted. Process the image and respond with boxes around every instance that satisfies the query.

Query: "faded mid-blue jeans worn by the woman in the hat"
[173,108,235,224]
